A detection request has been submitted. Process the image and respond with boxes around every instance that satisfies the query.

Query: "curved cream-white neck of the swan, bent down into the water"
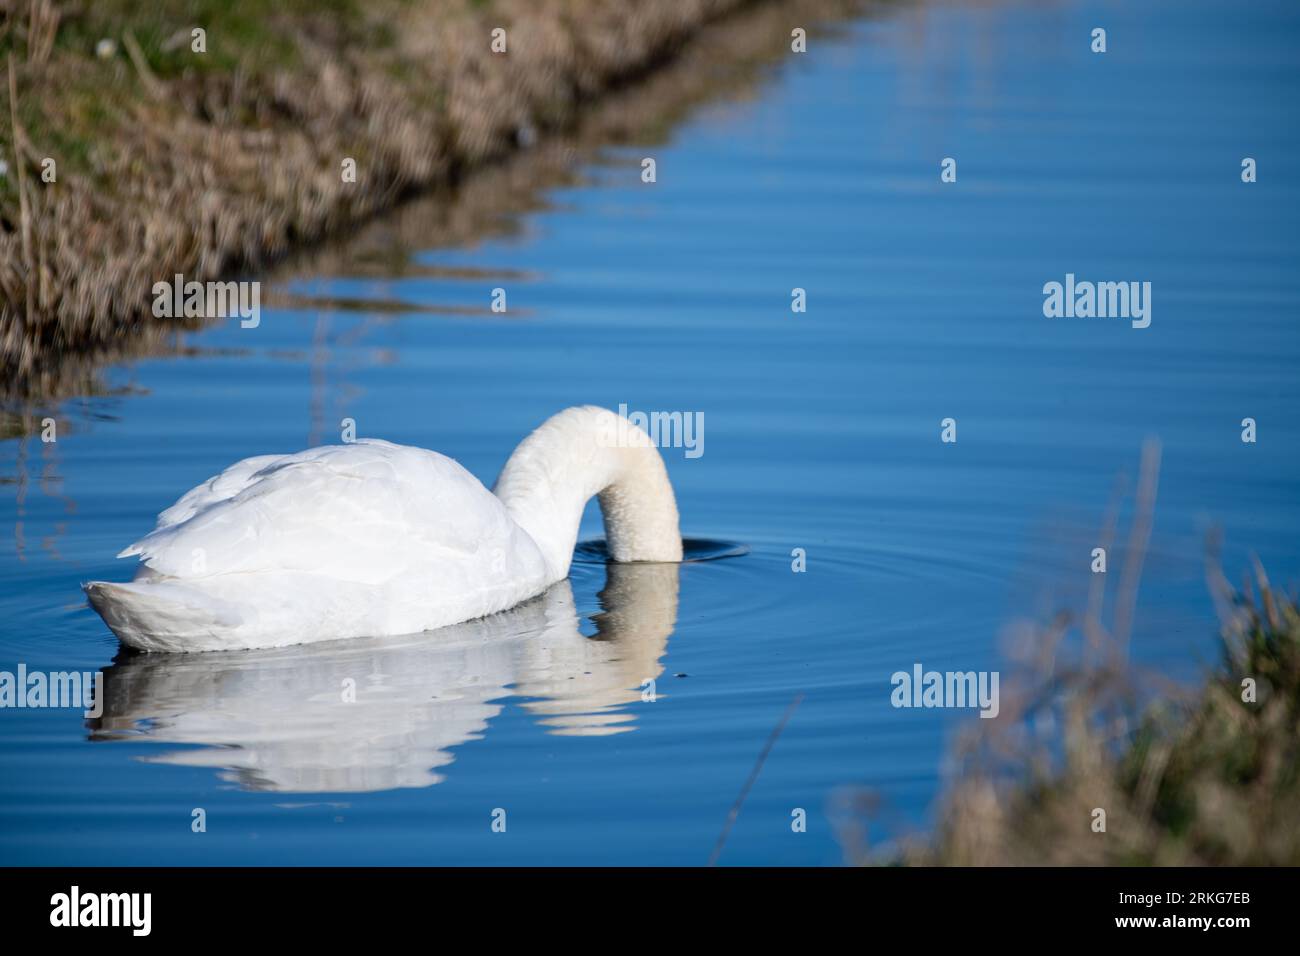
[493,406,681,580]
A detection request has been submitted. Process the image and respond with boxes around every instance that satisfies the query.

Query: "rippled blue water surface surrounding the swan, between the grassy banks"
[0,0,1300,865]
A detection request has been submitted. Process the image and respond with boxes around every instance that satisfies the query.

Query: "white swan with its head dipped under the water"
[83,406,681,652]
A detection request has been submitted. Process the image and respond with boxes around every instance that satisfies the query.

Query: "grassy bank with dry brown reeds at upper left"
[0,0,832,378]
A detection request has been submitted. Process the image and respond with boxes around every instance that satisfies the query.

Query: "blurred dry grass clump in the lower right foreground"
[848,444,1300,866]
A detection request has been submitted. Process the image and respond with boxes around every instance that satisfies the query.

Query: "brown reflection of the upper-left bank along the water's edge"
[0,0,862,413]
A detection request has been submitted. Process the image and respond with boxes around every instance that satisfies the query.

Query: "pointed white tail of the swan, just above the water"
[82,581,242,650]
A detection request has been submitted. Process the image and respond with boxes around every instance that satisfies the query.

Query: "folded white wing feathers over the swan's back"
[124,440,514,583]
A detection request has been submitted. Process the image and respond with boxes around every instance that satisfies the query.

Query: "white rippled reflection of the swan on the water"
[88,563,679,793]
